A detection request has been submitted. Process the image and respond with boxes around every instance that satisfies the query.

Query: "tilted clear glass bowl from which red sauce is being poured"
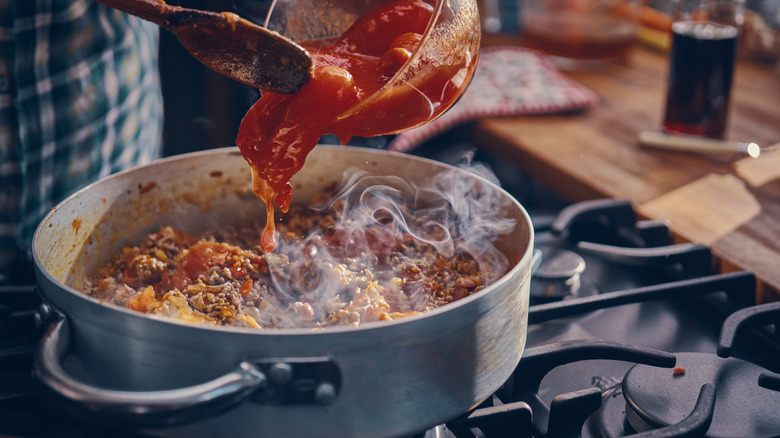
[253,0,480,137]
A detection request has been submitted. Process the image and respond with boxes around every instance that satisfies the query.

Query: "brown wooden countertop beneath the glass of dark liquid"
[473,42,780,301]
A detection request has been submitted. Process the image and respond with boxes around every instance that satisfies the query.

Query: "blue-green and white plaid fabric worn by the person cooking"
[0,0,162,269]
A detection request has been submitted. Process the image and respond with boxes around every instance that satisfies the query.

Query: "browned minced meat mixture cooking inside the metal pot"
[86,192,505,329]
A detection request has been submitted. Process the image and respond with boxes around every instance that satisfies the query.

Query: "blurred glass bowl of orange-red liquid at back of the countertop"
[521,0,641,59]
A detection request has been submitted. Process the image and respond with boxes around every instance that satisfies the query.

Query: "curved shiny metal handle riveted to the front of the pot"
[34,317,340,428]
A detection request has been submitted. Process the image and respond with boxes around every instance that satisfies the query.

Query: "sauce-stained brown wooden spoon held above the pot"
[95,0,312,94]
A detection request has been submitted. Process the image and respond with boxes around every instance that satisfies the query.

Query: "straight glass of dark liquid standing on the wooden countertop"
[664,21,738,138]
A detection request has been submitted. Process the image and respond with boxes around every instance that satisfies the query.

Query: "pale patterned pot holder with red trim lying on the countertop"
[388,46,598,152]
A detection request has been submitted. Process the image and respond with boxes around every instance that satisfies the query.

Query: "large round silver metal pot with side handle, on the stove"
[33,145,533,437]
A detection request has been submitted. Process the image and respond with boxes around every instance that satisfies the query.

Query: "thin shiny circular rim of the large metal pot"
[32,144,534,336]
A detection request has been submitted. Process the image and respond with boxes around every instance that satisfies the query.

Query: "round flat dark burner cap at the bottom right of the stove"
[623,353,780,437]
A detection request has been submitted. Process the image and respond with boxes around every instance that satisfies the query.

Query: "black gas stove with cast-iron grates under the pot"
[0,190,780,438]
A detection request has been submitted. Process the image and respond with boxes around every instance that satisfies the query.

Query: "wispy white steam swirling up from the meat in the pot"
[250,155,515,327]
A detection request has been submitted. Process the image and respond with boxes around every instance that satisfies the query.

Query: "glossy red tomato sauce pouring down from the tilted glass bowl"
[236,0,476,252]
